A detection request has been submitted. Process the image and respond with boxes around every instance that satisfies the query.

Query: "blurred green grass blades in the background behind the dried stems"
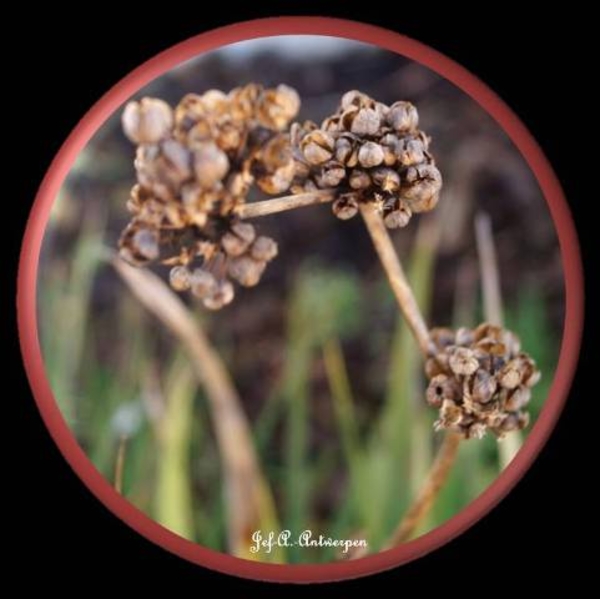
[39,202,557,562]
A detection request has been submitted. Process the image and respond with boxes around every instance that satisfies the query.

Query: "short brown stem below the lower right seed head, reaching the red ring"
[384,433,461,549]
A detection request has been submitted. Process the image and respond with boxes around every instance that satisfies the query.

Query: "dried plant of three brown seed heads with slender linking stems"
[120,84,540,546]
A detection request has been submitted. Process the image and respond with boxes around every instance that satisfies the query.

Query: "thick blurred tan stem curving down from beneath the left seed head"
[112,258,276,557]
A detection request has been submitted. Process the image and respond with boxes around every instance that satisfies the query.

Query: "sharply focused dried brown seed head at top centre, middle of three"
[291,91,442,228]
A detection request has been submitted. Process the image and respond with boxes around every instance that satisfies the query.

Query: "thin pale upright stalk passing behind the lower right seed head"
[475,212,523,469]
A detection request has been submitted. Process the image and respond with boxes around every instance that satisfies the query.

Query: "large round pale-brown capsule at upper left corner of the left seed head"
[121,98,173,144]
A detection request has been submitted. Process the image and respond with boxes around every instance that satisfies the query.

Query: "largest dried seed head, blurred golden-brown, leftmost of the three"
[120,84,300,309]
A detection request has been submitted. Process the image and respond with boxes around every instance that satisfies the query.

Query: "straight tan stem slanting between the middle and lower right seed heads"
[360,204,435,356]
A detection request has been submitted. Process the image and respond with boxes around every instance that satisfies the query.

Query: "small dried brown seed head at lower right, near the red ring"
[425,323,540,438]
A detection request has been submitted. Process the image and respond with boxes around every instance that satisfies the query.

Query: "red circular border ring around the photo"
[17,17,583,582]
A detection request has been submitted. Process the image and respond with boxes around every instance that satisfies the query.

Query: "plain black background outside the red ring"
[9,2,600,596]
